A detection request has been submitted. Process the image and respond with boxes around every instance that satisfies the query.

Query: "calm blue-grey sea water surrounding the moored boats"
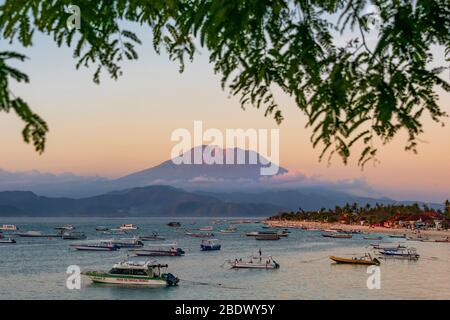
[0,218,450,300]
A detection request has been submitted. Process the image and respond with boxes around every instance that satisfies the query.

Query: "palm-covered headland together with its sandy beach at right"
[265,200,450,239]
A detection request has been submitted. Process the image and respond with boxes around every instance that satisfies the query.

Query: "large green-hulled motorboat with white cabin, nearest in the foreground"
[81,261,179,287]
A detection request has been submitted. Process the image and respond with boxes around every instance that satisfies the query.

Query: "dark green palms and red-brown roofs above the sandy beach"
[268,200,450,229]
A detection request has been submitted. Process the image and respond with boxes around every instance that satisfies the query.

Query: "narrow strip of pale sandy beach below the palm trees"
[264,220,450,240]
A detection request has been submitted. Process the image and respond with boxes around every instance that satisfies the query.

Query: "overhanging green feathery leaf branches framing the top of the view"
[0,0,450,165]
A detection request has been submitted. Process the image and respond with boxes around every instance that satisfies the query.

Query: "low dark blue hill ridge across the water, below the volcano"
[0,186,284,217]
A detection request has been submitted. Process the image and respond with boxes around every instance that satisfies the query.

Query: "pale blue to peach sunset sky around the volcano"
[0,28,450,202]
